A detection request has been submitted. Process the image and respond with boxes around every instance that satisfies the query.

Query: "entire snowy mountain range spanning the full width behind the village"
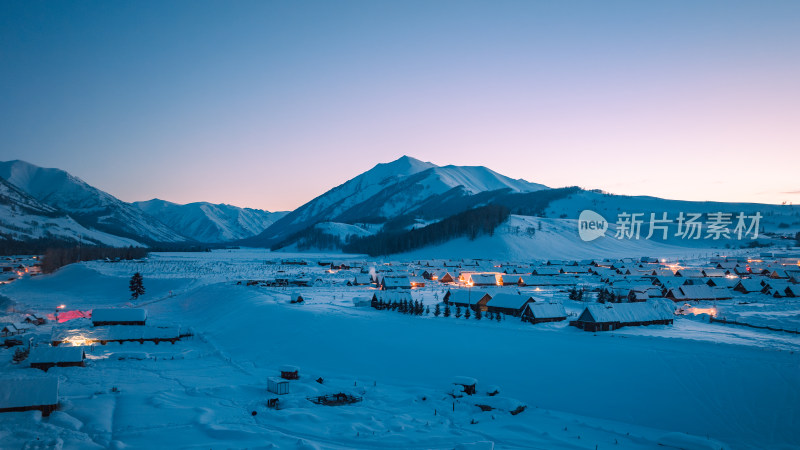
[0,156,800,257]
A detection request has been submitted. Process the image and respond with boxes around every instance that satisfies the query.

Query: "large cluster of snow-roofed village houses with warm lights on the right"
[248,251,800,332]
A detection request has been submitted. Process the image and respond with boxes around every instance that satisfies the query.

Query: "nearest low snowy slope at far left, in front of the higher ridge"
[0,178,141,247]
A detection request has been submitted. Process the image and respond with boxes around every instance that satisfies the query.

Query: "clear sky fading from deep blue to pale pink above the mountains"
[0,0,800,210]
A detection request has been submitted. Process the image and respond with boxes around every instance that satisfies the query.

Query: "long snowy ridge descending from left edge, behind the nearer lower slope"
[0,161,187,242]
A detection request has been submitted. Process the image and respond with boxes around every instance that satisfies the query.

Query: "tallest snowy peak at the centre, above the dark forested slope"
[253,156,547,244]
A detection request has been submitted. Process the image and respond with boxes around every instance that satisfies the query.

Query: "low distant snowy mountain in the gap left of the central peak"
[133,199,287,243]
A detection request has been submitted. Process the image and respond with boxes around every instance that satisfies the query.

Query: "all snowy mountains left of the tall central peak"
[0,161,283,246]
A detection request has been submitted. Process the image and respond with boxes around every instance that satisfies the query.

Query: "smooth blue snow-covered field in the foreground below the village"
[0,250,800,449]
